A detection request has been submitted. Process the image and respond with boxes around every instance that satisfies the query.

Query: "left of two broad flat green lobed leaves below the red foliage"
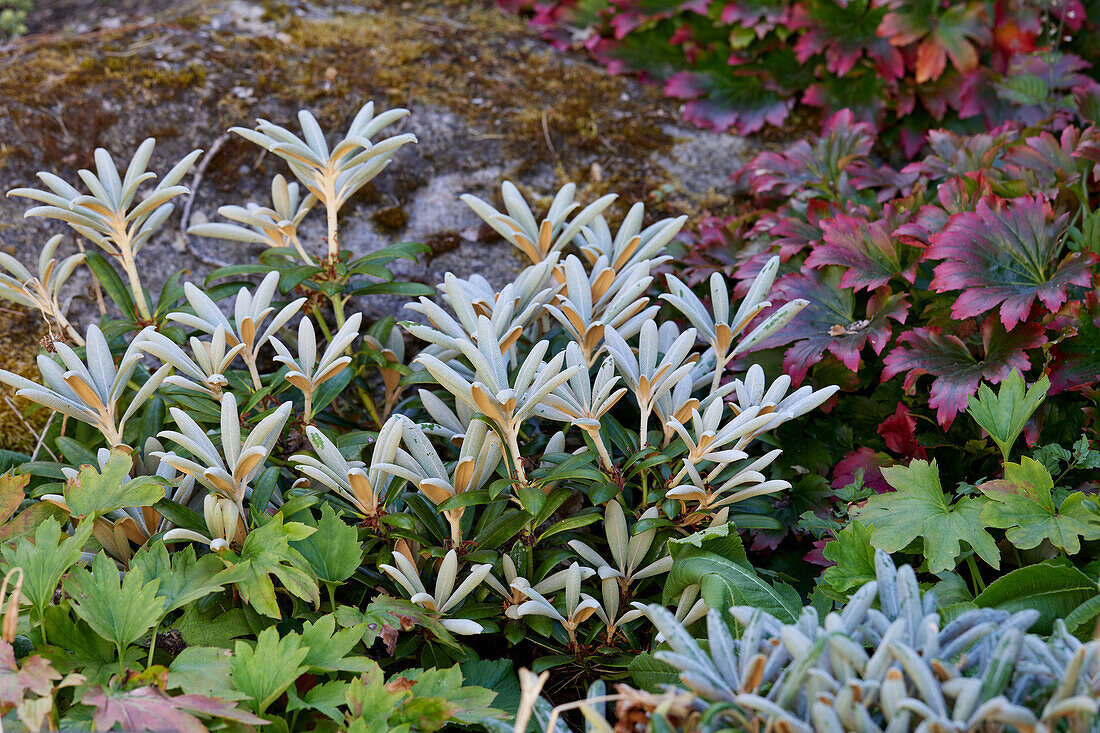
[859,460,1001,572]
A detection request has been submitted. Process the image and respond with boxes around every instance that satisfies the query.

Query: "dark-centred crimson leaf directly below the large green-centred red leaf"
[882,316,1046,429]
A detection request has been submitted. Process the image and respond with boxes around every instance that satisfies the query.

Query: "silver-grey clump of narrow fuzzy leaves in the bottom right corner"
[639,550,1100,733]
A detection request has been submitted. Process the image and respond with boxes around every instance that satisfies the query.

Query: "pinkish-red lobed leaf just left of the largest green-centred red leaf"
[806,205,920,292]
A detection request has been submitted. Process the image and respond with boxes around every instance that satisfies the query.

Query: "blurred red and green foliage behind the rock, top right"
[498,0,1098,154]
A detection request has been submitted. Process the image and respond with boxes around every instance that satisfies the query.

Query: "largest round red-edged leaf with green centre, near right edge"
[925,196,1095,329]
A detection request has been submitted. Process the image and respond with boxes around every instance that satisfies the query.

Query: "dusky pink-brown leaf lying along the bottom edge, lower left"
[80,686,268,733]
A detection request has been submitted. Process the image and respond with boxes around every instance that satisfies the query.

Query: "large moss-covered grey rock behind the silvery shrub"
[0,0,792,448]
